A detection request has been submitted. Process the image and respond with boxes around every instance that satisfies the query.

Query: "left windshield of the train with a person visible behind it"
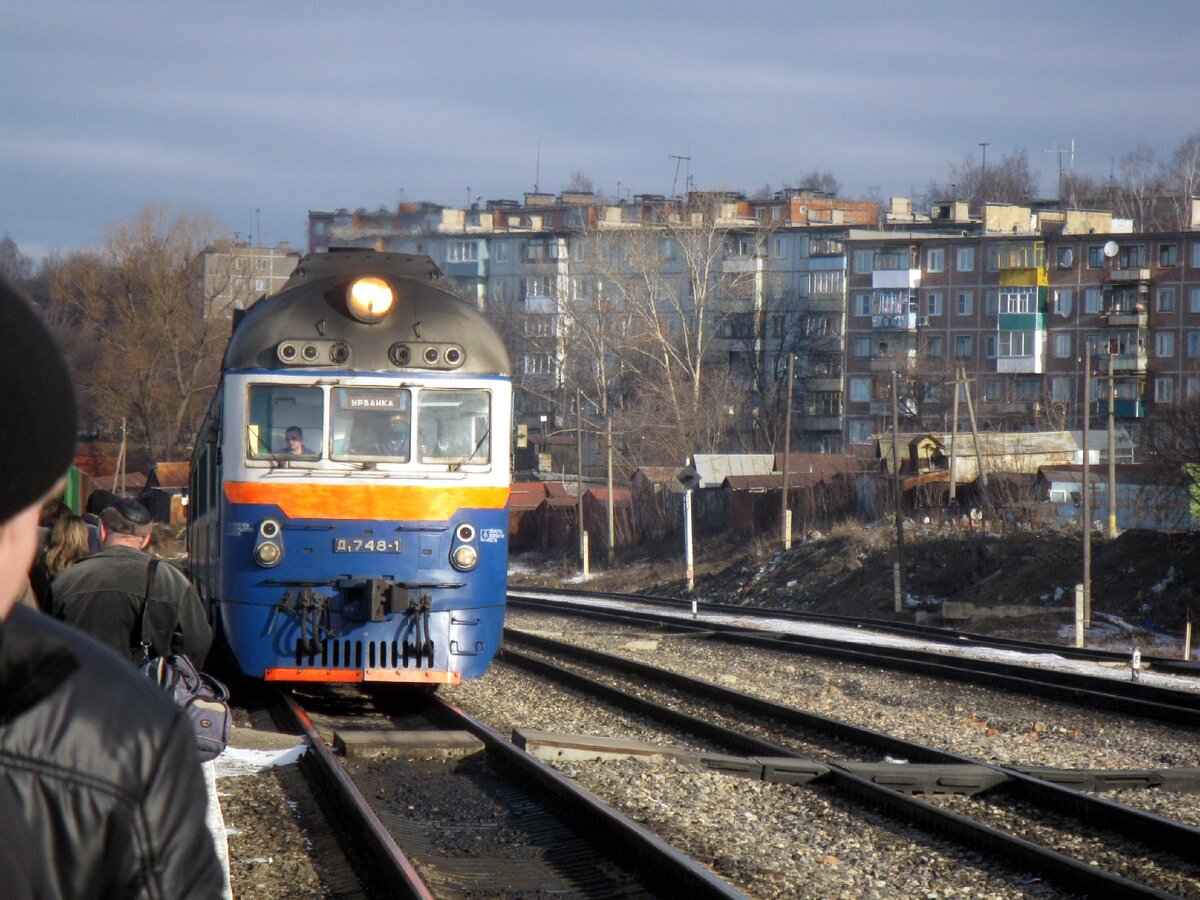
[246,384,325,460]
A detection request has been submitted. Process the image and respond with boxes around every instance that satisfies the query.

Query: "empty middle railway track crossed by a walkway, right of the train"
[504,630,1200,896]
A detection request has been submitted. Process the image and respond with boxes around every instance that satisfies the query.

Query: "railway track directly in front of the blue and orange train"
[274,695,743,898]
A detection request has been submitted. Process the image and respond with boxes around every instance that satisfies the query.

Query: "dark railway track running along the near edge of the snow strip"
[509,590,1200,726]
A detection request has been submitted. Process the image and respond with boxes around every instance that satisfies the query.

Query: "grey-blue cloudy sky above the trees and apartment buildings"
[0,0,1200,257]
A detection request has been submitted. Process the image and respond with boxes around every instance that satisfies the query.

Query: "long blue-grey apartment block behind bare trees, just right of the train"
[308,190,878,451]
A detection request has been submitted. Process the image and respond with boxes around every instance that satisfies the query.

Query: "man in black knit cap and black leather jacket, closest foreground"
[0,271,224,900]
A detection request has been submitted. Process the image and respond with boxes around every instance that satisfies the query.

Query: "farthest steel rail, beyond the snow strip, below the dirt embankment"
[510,588,1200,676]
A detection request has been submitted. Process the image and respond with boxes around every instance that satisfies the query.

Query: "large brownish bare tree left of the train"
[48,205,229,463]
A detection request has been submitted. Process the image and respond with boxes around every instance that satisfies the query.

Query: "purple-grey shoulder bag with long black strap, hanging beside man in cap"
[138,559,233,762]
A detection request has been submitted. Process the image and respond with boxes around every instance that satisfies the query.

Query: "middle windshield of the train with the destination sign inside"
[330,388,413,462]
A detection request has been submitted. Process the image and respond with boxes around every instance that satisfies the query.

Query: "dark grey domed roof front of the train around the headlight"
[223,250,511,376]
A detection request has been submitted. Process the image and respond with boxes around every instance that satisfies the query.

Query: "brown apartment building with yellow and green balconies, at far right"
[845,205,1200,448]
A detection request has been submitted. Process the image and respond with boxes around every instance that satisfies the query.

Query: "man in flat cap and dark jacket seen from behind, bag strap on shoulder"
[49,499,212,668]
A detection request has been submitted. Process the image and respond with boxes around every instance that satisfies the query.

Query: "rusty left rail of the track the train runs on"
[282,694,434,900]
